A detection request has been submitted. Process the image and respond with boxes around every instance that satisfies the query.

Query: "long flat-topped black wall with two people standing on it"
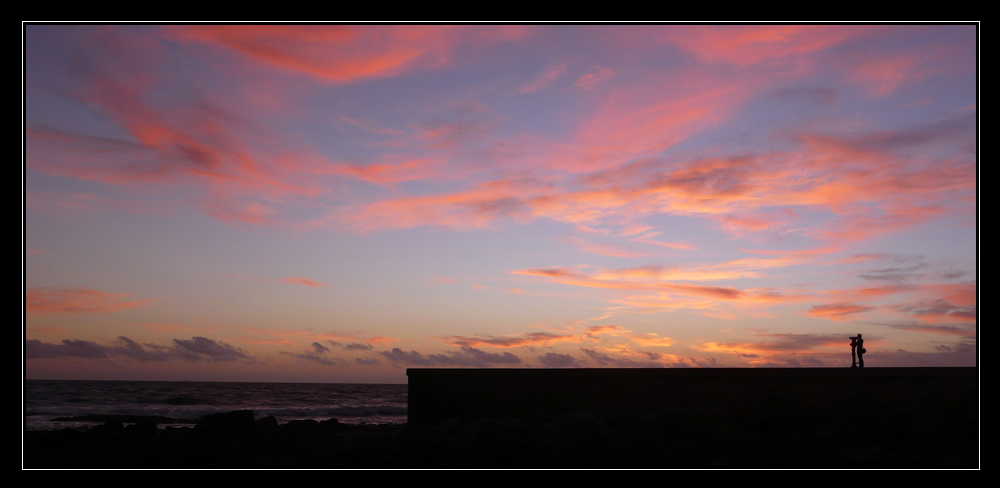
[407,368,978,423]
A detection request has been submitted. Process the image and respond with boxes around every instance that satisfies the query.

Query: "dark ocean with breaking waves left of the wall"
[22,380,406,430]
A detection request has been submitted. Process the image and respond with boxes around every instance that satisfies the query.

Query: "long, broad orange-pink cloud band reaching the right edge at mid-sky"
[322,108,974,244]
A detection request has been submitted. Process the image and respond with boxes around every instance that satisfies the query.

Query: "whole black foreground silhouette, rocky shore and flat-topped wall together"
[24,368,980,468]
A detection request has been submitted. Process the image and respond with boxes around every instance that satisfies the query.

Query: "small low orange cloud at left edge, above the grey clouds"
[24,286,159,315]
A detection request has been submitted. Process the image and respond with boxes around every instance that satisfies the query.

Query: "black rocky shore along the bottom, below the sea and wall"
[24,408,979,469]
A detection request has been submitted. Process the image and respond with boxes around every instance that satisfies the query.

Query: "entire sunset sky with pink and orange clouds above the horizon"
[22,25,978,383]
